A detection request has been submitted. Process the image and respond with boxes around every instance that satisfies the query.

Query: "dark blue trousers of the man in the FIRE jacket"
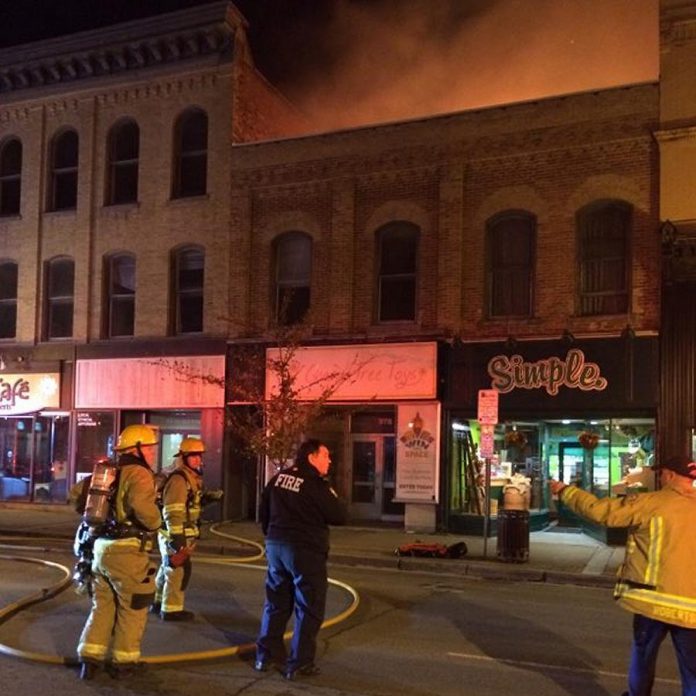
[256,541,327,671]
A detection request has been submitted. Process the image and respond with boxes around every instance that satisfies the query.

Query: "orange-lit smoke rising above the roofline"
[282,0,658,130]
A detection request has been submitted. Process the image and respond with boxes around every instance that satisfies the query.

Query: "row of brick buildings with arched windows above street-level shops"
[0,2,696,530]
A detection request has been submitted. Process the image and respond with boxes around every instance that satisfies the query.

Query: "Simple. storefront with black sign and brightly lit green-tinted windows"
[443,332,658,540]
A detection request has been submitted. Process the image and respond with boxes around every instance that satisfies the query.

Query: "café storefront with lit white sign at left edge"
[0,358,70,503]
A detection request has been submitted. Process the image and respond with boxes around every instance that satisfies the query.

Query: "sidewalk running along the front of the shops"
[0,503,624,587]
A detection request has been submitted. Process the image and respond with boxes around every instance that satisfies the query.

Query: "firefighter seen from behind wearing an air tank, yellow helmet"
[77,425,162,679]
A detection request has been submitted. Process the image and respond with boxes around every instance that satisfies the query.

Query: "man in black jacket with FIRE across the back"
[254,440,347,680]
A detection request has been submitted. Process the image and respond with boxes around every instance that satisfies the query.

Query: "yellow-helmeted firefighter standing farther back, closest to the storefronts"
[150,437,222,621]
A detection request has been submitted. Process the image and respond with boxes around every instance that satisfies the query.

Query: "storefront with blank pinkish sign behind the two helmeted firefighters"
[73,355,225,498]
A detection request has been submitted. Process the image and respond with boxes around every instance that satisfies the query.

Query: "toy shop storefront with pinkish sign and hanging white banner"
[234,342,441,530]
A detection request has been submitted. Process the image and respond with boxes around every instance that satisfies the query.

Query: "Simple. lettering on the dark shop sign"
[488,348,607,396]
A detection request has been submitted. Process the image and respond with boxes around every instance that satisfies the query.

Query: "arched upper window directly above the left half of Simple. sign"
[486,211,536,317]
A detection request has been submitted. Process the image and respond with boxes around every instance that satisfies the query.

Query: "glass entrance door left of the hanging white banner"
[350,435,404,520]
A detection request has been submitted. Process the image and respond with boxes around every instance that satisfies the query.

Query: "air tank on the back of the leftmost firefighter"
[73,460,118,596]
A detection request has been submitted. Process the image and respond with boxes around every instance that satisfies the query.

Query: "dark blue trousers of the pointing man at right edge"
[628,614,696,696]
